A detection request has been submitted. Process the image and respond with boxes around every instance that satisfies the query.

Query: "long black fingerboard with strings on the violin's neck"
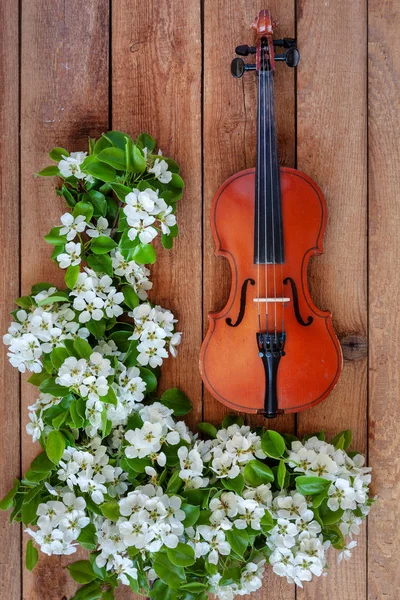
[254,70,284,264]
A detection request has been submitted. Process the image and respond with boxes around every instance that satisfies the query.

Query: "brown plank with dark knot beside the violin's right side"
[297,0,367,600]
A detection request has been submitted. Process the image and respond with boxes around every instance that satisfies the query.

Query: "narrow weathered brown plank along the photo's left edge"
[0,0,21,599]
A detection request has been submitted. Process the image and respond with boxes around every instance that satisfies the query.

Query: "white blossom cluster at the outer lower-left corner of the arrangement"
[25,486,90,555]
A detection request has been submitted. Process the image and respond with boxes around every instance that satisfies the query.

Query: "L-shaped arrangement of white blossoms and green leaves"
[0,131,372,600]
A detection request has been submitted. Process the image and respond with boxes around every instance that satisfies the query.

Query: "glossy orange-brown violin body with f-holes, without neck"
[200,167,342,416]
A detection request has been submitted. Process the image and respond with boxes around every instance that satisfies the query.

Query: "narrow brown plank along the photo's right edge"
[368,0,400,600]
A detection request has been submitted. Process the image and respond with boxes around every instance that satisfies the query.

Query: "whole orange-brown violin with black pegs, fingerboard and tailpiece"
[200,10,342,418]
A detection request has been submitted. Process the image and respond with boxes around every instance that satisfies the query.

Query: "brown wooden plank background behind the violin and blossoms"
[0,0,400,600]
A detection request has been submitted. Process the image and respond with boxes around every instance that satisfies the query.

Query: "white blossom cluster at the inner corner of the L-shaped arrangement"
[125,402,191,466]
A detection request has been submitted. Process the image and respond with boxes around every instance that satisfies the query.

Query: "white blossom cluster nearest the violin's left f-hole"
[128,302,182,368]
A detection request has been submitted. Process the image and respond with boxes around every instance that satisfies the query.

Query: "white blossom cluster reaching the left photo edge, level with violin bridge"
[3,288,89,373]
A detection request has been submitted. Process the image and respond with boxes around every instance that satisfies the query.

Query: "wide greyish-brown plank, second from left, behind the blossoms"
[20,0,108,600]
